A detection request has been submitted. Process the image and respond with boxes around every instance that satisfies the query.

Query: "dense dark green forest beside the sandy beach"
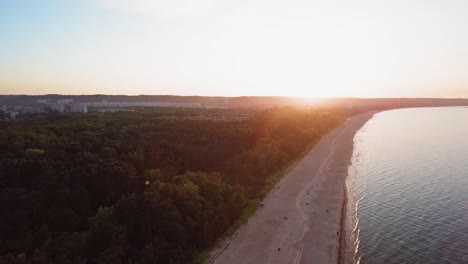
[0,107,352,264]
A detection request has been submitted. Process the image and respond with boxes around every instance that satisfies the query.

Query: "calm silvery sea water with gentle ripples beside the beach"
[347,107,468,264]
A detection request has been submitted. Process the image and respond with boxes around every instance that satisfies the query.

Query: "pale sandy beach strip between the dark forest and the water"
[210,113,374,264]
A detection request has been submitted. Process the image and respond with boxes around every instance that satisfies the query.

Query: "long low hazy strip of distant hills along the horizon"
[0,94,468,109]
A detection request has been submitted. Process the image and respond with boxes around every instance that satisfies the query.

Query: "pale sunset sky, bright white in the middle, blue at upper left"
[0,0,468,98]
